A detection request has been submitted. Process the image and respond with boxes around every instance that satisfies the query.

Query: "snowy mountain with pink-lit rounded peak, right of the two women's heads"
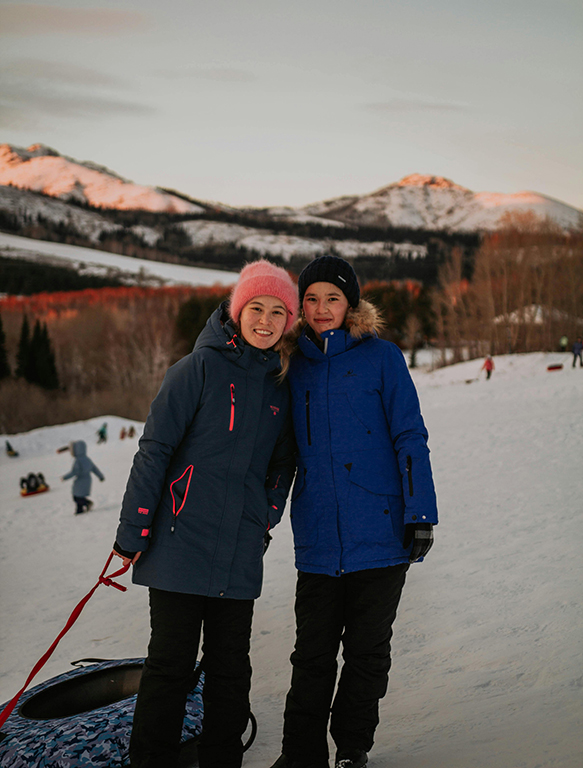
[296,173,583,232]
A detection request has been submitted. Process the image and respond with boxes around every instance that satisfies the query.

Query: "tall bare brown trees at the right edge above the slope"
[434,214,583,362]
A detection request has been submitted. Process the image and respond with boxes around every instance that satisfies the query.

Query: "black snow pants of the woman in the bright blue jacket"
[283,565,409,762]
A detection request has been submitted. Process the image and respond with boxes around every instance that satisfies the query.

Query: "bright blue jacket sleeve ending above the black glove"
[383,344,437,525]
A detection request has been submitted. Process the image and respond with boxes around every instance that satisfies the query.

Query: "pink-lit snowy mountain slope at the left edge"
[0,144,204,214]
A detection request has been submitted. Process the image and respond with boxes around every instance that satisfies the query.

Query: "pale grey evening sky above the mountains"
[0,0,583,208]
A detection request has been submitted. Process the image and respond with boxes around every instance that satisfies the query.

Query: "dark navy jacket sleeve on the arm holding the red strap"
[116,353,204,552]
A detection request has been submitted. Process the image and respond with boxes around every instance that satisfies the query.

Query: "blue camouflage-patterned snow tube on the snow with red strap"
[0,658,203,768]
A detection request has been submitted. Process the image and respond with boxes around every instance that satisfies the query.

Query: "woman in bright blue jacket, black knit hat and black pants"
[272,256,437,768]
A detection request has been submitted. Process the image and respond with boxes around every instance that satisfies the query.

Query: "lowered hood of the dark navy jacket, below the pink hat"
[194,301,279,370]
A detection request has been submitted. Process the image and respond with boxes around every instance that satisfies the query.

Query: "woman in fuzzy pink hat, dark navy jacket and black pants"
[114,260,298,768]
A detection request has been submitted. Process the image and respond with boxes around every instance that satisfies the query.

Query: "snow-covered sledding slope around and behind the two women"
[0,353,583,768]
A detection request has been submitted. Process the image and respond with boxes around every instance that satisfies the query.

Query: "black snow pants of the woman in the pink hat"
[130,588,253,768]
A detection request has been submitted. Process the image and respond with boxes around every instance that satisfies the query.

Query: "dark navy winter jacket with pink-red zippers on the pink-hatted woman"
[116,305,295,599]
